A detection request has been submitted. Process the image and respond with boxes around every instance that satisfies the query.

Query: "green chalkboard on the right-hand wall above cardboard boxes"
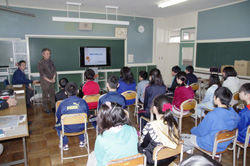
[196,41,250,68]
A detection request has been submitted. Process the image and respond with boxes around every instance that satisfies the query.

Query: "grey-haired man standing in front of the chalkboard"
[38,48,56,113]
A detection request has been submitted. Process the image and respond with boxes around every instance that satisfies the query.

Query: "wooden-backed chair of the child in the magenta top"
[173,99,197,133]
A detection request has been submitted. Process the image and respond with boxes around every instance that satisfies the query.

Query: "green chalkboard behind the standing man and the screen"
[29,38,125,73]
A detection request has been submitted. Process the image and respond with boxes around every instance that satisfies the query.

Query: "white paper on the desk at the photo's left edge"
[0,115,19,130]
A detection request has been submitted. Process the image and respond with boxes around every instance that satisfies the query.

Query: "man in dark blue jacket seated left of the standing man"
[12,60,39,107]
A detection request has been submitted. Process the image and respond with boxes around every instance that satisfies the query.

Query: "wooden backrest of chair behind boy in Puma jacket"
[61,113,87,126]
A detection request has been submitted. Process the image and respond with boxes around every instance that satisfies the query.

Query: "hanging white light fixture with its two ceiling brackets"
[52,2,129,25]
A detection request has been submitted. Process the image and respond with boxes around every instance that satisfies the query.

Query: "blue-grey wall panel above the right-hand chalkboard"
[197,1,250,40]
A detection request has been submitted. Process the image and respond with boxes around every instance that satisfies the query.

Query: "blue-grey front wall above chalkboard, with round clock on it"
[0,5,153,64]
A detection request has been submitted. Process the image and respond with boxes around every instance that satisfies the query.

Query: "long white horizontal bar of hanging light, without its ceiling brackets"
[52,17,129,25]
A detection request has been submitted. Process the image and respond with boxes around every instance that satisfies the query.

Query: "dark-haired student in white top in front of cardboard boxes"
[222,66,240,94]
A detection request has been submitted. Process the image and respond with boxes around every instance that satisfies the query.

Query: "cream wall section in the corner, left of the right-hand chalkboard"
[155,12,197,85]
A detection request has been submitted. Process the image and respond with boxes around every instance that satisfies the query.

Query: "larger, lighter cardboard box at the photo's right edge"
[234,60,250,76]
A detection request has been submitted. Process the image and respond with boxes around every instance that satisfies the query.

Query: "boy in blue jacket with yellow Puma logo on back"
[56,82,89,150]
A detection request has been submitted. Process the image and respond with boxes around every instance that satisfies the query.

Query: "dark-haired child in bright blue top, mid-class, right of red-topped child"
[117,67,136,105]
